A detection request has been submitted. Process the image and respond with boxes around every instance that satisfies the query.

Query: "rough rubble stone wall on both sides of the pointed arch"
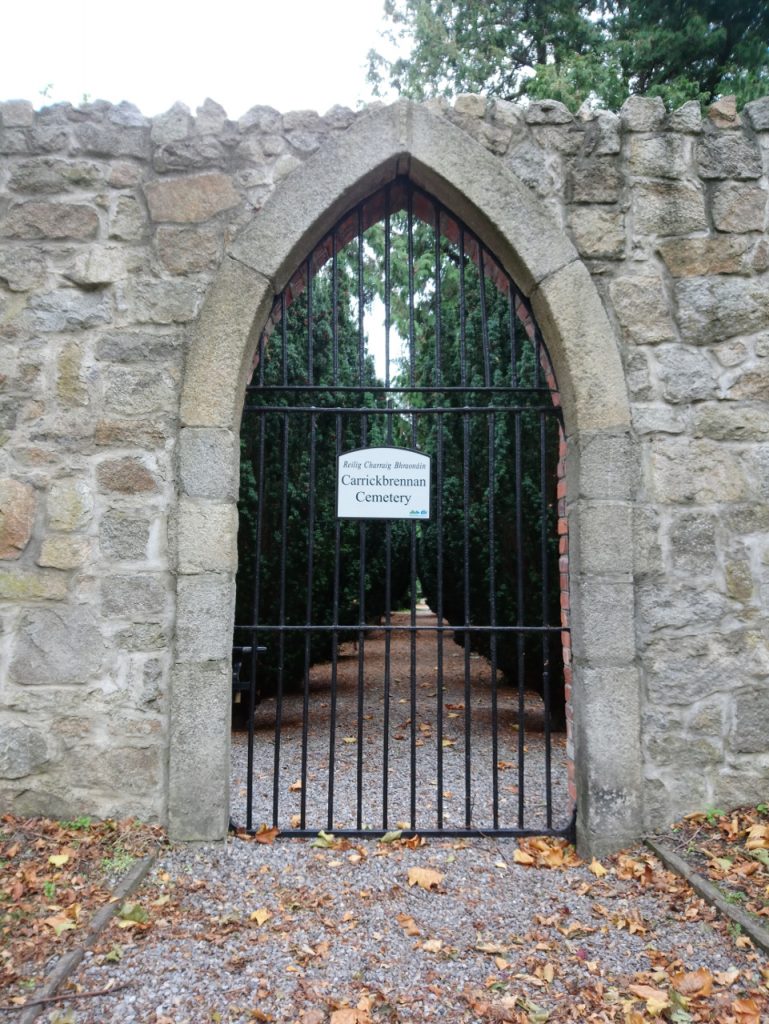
[0,88,769,839]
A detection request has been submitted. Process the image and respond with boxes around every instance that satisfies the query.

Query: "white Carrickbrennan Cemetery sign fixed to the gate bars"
[337,447,430,519]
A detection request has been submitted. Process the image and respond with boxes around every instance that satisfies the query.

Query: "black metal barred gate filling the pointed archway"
[233,179,573,836]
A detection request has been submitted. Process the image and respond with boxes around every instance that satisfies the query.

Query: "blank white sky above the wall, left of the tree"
[0,0,397,119]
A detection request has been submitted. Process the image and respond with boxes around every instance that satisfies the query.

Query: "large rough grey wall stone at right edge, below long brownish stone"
[675,274,769,345]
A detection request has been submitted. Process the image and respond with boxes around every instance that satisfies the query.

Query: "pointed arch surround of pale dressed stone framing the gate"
[168,101,641,852]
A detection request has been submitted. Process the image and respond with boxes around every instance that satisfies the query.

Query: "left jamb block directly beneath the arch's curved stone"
[179,427,240,501]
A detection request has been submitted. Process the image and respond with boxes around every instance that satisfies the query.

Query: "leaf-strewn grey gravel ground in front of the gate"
[39,840,769,1024]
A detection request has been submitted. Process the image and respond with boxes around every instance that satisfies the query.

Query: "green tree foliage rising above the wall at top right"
[369,0,769,110]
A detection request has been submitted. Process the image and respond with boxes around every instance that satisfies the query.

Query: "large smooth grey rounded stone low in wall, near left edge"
[8,602,108,686]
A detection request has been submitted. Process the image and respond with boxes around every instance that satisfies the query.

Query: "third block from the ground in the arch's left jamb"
[175,498,238,573]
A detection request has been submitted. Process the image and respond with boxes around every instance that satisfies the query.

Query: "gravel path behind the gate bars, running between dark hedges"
[231,608,570,831]
